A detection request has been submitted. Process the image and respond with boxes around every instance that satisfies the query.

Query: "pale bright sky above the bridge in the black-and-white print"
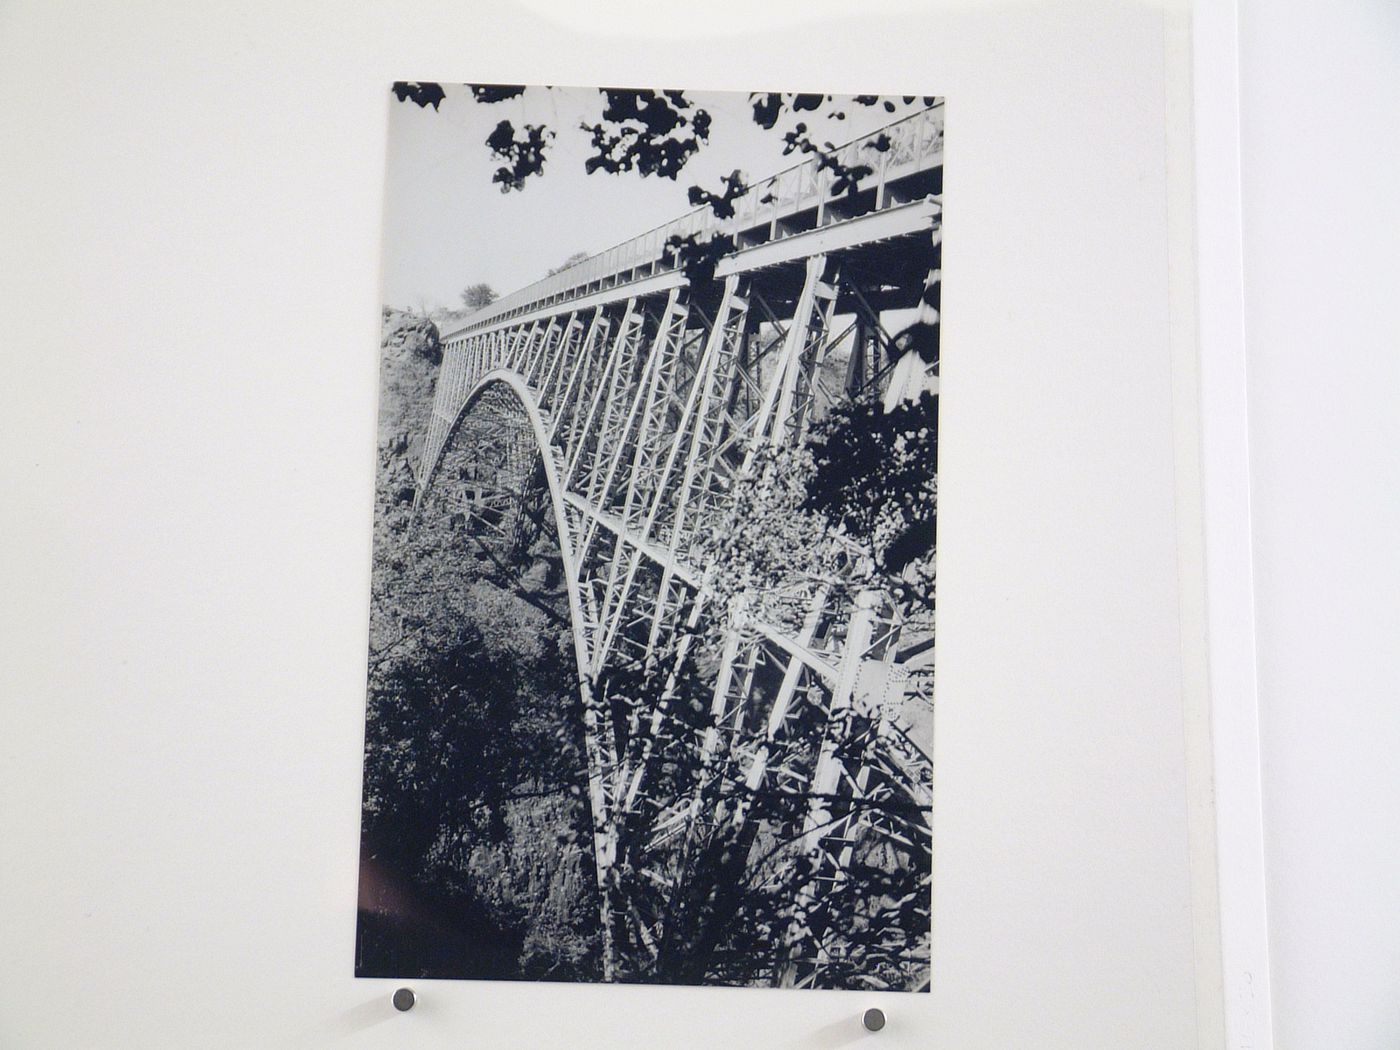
[384,85,910,309]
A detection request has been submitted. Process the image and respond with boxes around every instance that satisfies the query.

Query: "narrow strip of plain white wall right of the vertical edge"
[1240,0,1400,1050]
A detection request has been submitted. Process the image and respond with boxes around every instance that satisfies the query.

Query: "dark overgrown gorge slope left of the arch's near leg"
[357,341,598,980]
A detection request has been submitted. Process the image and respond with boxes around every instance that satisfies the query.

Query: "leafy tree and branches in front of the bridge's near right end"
[593,396,938,987]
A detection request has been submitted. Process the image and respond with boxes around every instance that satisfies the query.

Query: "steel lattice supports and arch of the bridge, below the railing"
[419,137,939,987]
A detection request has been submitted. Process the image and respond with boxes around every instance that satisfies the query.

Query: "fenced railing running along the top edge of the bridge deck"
[447,102,944,339]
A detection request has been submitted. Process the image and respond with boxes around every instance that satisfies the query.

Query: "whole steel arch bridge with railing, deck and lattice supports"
[416,105,942,987]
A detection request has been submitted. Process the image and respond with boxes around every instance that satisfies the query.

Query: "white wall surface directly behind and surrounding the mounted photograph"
[0,0,1219,1050]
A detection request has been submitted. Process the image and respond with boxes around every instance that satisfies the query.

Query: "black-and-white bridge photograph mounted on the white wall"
[356,83,944,991]
